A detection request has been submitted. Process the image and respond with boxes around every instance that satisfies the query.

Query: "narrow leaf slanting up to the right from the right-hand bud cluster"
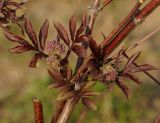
[124,51,141,73]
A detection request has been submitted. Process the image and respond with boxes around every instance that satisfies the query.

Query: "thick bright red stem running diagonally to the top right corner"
[103,0,160,56]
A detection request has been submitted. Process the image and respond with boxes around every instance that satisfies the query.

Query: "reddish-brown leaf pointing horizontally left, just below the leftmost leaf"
[9,45,32,53]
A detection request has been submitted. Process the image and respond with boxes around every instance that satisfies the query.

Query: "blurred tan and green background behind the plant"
[0,0,160,123]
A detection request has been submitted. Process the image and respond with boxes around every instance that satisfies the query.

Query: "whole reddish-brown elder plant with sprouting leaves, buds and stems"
[0,0,160,123]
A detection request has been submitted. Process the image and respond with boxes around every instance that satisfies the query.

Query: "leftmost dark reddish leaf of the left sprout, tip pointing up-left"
[4,30,26,43]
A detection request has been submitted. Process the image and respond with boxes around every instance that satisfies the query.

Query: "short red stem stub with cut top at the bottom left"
[33,97,43,123]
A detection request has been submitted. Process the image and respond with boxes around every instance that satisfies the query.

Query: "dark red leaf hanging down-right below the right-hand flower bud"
[116,80,129,100]
